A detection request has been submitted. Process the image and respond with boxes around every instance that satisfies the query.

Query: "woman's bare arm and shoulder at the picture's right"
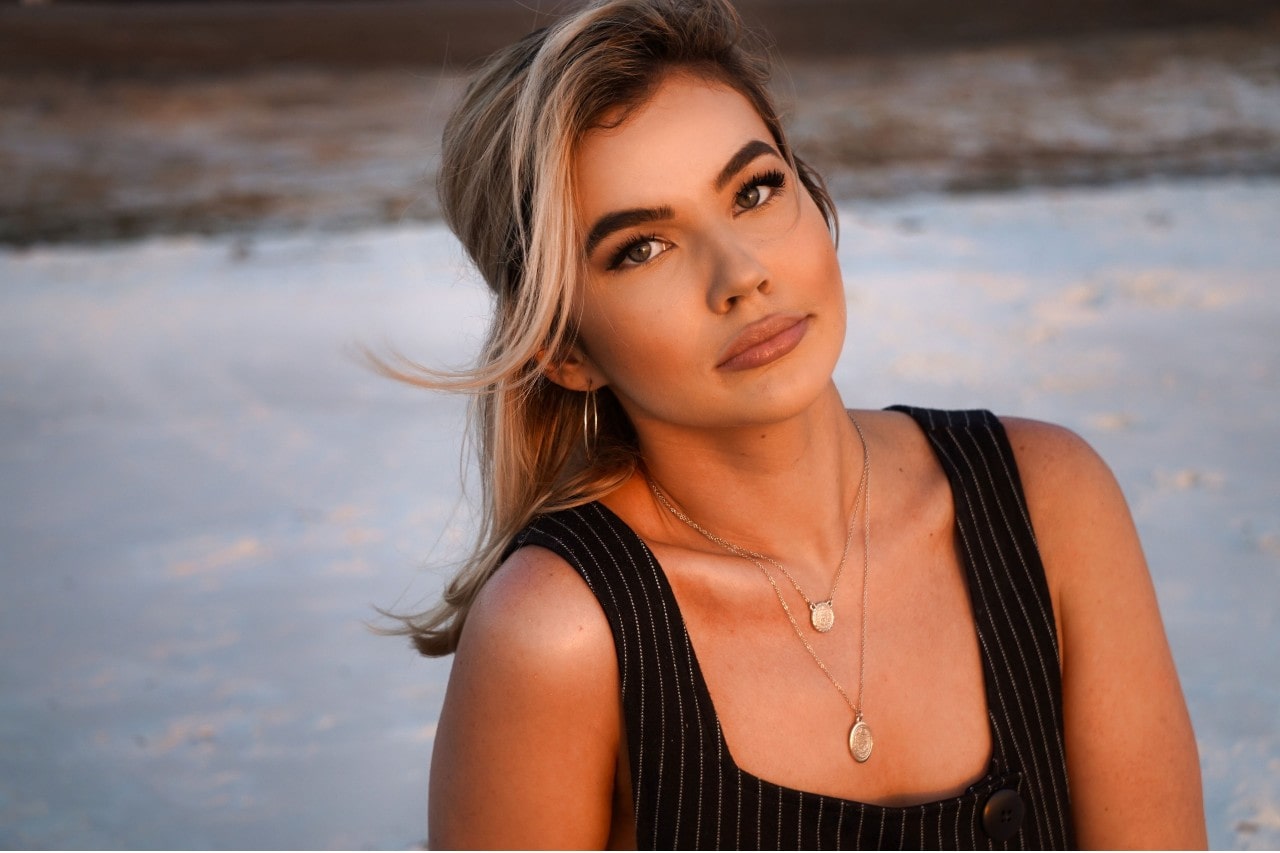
[1005,419,1207,849]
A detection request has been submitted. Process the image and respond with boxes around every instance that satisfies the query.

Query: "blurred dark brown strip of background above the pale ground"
[0,0,1280,245]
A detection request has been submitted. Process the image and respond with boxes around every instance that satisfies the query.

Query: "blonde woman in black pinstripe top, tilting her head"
[384,0,1204,848]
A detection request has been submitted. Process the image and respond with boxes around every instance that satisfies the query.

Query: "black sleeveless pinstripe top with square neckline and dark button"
[512,407,1075,849]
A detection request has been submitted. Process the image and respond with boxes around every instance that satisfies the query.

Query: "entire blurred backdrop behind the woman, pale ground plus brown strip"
[0,0,1280,849]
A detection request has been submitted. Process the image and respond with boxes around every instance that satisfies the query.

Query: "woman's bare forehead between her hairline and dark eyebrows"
[573,72,773,216]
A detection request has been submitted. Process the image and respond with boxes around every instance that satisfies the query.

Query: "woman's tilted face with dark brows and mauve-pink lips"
[575,73,845,434]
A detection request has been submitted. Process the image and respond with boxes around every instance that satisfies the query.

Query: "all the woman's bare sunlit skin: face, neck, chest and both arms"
[429,72,1206,848]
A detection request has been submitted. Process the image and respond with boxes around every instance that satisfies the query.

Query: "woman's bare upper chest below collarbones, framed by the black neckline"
[658,479,992,804]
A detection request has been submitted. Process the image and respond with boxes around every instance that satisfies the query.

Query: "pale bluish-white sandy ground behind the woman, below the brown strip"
[0,179,1280,848]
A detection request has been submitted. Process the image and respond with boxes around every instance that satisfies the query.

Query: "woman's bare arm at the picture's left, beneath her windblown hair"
[428,548,620,849]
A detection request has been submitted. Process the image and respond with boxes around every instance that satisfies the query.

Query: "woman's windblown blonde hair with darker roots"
[378,0,836,656]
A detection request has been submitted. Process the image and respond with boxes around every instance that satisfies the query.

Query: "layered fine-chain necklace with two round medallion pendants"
[645,414,876,763]
